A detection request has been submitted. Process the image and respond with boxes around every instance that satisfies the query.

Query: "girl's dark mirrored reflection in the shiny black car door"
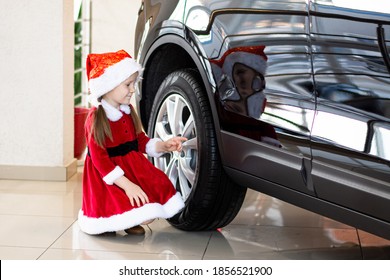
[211,46,280,147]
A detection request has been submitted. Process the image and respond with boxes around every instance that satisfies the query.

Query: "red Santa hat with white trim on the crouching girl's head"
[87,50,143,107]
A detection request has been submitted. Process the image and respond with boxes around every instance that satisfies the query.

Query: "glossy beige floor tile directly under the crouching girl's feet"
[51,220,211,259]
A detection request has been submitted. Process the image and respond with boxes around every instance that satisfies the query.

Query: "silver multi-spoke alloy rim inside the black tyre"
[153,94,198,200]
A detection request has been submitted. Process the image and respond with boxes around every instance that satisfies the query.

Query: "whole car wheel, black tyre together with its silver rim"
[148,69,246,231]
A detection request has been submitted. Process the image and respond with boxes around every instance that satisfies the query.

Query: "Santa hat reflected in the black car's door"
[211,46,267,75]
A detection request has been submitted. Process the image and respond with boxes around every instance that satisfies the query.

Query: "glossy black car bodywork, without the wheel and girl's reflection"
[135,0,390,239]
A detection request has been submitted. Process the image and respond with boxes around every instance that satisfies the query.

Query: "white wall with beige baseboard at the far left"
[0,0,75,180]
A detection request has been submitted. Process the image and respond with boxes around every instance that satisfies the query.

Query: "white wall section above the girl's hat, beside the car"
[91,0,141,56]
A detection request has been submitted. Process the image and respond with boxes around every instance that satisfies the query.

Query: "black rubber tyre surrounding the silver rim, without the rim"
[148,69,246,231]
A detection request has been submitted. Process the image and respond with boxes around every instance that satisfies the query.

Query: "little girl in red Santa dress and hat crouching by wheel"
[78,50,187,234]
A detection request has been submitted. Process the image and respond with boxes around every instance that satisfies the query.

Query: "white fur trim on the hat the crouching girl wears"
[88,57,143,107]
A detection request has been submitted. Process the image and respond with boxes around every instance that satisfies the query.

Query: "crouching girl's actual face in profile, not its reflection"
[103,72,138,109]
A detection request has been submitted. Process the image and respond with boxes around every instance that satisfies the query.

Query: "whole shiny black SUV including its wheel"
[135,0,390,239]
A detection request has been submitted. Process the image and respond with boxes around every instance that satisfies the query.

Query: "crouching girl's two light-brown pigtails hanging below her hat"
[91,101,143,148]
